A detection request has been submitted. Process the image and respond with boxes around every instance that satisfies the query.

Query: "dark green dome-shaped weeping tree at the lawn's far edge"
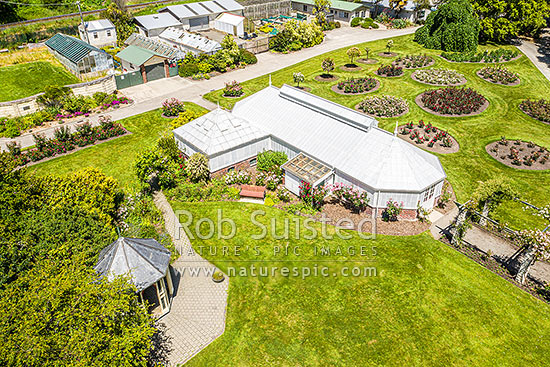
[414,0,479,52]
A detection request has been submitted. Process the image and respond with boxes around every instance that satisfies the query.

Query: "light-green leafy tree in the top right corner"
[471,0,550,42]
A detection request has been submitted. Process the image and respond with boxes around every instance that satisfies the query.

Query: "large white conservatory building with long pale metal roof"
[173,85,446,213]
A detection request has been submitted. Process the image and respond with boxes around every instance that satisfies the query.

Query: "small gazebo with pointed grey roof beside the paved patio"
[95,237,174,316]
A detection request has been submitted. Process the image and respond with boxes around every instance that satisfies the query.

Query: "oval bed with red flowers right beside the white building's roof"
[398,120,460,154]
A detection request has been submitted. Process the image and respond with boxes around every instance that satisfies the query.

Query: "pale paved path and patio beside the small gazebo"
[154,192,229,365]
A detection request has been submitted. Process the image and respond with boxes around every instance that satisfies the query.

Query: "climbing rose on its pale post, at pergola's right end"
[515,229,550,284]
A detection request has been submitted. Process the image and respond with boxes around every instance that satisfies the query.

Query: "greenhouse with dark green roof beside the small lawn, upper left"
[45,33,114,78]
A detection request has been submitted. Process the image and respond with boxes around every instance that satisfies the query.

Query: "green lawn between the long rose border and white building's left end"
[29,103,205,186]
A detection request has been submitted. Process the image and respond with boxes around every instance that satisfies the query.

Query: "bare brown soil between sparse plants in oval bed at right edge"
[485,140,550,171]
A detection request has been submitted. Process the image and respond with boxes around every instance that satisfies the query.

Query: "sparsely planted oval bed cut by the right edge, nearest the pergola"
[485,137,550,170]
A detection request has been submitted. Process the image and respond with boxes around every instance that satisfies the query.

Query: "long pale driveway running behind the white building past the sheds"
[0,26,416,150]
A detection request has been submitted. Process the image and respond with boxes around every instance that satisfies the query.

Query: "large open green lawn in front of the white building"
[172,203,550,366]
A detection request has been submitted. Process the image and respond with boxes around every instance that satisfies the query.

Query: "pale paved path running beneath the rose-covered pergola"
[430,207,550,283]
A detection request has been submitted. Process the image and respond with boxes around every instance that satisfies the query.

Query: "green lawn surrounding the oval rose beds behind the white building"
[205,35,550,230]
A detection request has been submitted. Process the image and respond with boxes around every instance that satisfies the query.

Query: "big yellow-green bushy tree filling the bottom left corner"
[0,260,155,367]
